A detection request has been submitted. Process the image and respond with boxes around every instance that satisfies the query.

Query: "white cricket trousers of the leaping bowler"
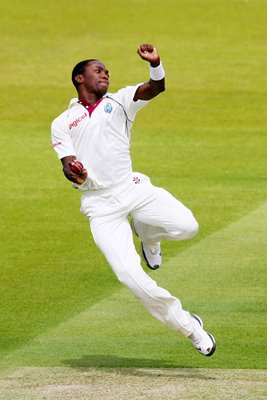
[81,173,198,336]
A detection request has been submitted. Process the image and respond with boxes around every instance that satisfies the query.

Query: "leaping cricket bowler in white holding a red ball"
[52,44,216,356]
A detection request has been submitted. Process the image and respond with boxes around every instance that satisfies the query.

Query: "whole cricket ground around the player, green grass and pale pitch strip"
[0,0,267,400]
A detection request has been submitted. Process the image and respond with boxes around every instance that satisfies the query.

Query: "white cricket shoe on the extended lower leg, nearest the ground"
[188,314,216,357]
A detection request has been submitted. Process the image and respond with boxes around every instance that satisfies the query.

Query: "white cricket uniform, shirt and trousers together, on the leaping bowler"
[52,85,198,336]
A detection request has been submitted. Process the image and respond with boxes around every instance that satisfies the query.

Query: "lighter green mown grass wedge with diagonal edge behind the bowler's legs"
[1,203,267,369]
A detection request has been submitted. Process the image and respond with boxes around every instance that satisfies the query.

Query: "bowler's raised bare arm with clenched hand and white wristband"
[134,44,165,101]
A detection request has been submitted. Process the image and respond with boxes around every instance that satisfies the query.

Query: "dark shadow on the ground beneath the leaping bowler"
[62,354,214,380]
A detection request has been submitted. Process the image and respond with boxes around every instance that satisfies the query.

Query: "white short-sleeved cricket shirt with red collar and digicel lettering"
[52,83,148,190]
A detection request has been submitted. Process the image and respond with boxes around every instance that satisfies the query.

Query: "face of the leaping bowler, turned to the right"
[80,61,109,96]
